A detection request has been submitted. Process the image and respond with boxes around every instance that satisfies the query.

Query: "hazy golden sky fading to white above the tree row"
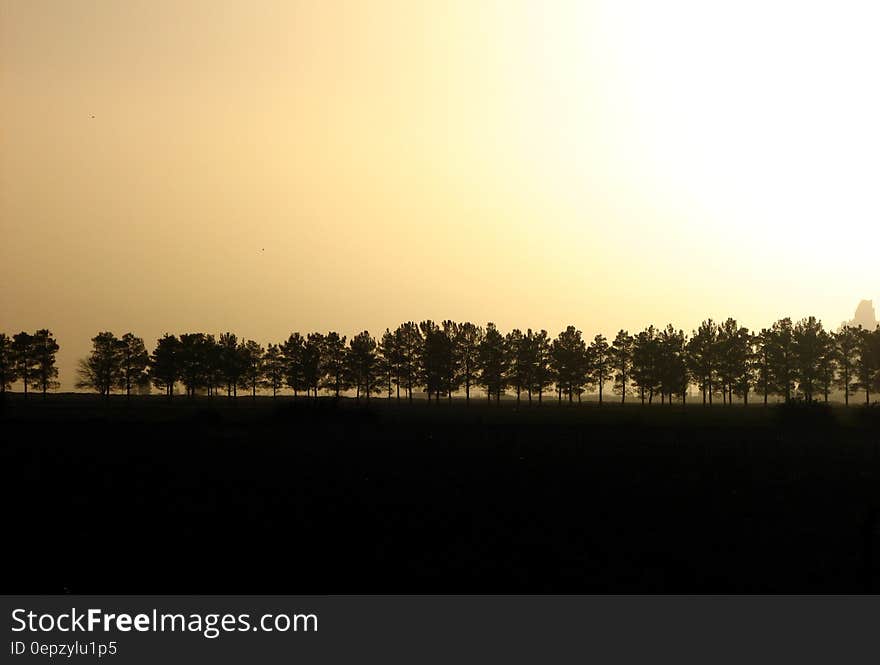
[0,0,880,388]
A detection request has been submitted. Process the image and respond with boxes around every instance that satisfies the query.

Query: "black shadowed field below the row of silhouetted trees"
[0,395,880,593]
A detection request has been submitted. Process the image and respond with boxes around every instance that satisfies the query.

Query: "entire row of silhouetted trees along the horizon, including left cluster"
[0,317,880,404]
